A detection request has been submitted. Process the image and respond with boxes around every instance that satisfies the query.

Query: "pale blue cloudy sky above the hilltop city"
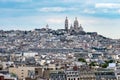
[0,0,120,39]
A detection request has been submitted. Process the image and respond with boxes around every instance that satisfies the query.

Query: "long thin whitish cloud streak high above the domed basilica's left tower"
[38,7,76,12]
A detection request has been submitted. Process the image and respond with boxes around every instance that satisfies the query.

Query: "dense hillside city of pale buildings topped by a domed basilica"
[0,17,120,80]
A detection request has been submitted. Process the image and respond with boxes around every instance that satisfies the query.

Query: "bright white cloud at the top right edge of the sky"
[95,3,120,9]
